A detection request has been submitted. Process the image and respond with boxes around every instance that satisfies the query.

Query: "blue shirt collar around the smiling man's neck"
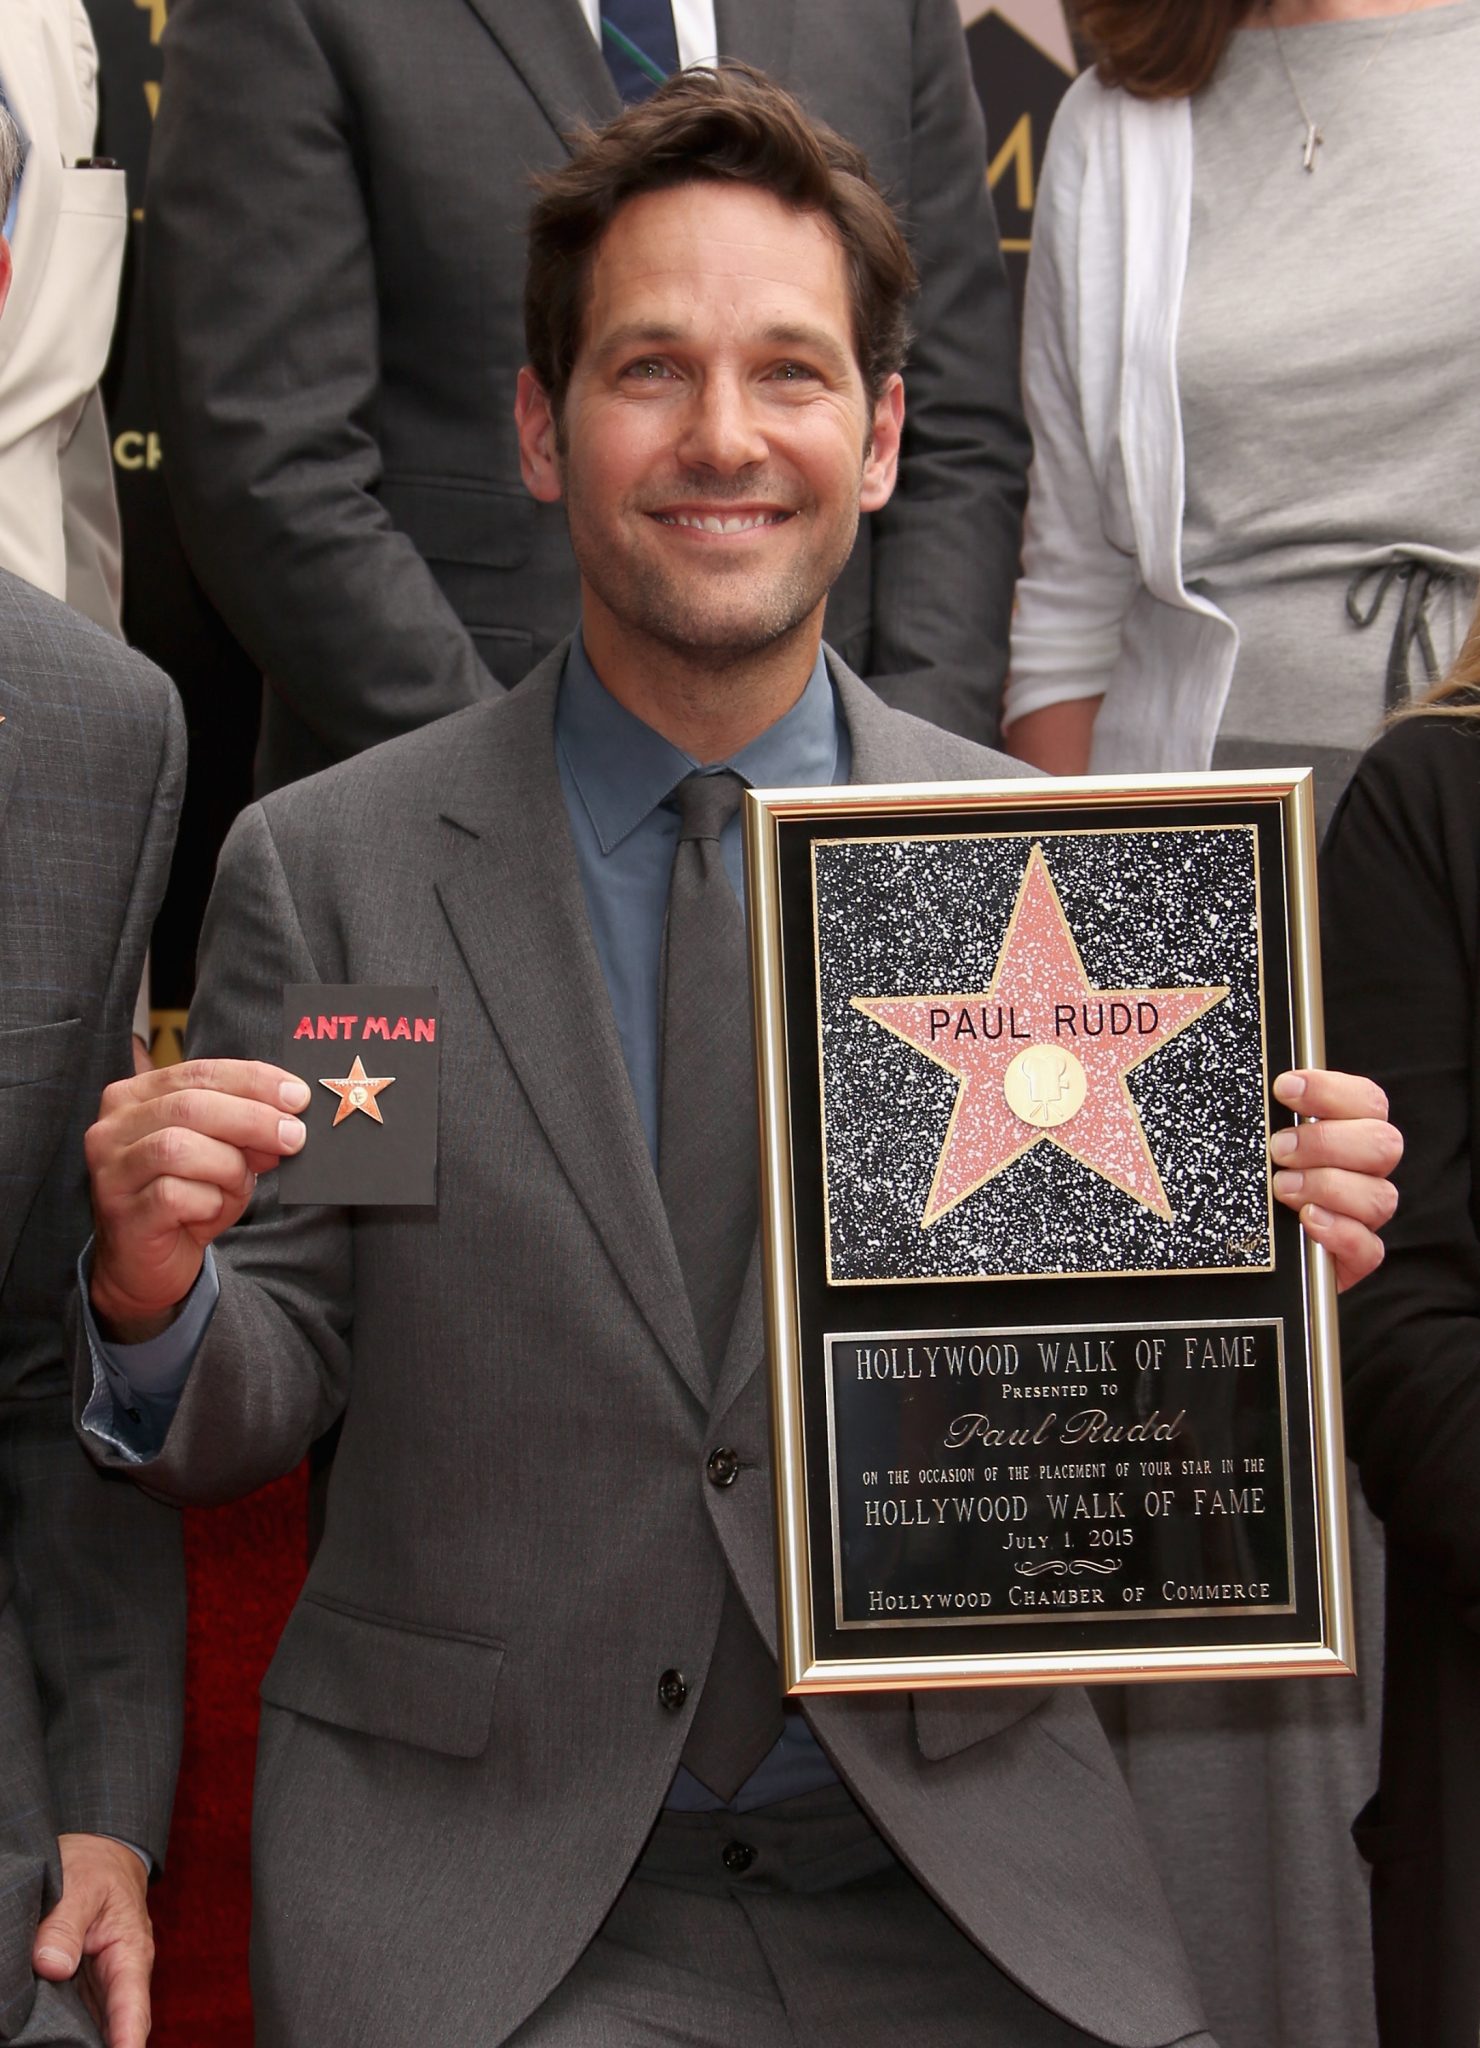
[555,631,841,854]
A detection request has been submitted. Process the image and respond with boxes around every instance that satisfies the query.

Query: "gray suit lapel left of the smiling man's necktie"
[436,647,708,1405]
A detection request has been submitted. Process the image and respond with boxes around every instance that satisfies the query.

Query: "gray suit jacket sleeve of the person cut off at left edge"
[0,647,184,1862]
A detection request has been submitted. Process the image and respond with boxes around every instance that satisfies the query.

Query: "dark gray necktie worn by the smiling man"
[657,770,782,1800]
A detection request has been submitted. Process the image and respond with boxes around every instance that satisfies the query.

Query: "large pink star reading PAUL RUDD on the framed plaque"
[852,846,1228,1229]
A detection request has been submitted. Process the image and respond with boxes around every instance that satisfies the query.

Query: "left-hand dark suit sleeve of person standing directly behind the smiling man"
[145,0,503,756]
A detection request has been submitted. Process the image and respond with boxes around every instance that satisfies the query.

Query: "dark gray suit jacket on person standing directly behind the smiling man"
[145,0,1028,788]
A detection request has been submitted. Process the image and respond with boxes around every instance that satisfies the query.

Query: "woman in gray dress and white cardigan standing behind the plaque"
[1005,0,1480,2048]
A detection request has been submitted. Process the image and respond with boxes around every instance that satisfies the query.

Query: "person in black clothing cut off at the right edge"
[1322,598,1480,2048]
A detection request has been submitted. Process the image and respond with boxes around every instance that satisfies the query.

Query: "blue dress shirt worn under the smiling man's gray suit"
[80,633,852,1812]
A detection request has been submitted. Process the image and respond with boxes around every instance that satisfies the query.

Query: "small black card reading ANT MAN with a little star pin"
[278,981,438,1206]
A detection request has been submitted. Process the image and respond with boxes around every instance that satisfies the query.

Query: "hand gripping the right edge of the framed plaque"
[1269,1067,1402,1288]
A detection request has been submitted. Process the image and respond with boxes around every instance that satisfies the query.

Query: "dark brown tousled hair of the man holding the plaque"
[524,63,917,418]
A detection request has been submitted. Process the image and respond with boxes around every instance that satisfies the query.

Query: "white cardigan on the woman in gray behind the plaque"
[1005,74,1238,770]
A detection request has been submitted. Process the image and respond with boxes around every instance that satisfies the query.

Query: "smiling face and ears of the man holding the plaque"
[518,182,903,737]
